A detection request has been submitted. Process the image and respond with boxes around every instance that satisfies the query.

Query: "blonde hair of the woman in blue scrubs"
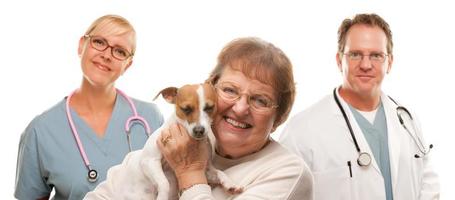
[85,15,136,54]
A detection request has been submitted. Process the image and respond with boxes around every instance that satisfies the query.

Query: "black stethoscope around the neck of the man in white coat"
[333,88,433,166]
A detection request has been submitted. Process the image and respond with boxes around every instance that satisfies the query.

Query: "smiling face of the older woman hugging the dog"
[212,67,277,158]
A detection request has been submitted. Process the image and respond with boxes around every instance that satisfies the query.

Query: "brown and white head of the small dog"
[155,83,217,139]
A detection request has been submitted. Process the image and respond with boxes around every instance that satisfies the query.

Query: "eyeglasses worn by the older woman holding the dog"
[215,82,278,113]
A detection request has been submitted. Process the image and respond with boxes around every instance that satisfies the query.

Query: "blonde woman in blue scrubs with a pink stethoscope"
[14,15,163,199]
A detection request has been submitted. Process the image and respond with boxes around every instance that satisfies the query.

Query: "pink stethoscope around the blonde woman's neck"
[66,88,151,183]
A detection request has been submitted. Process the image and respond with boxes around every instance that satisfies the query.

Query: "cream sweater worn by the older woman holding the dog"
[85,141,313,200]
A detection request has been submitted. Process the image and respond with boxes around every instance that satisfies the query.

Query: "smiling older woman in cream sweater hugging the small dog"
[157,37,313,200]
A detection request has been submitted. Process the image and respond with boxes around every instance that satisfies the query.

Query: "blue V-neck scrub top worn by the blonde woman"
[14,95,164,199]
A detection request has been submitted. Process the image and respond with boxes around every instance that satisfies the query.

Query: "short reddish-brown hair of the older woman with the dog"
[208,37,295,130]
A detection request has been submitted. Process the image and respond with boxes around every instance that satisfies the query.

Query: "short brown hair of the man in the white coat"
[338,13,393,54]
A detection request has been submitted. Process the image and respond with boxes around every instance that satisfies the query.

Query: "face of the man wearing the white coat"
[337,24,392,97]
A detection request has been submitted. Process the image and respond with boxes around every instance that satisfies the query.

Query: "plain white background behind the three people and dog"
[0,0,455,199]
